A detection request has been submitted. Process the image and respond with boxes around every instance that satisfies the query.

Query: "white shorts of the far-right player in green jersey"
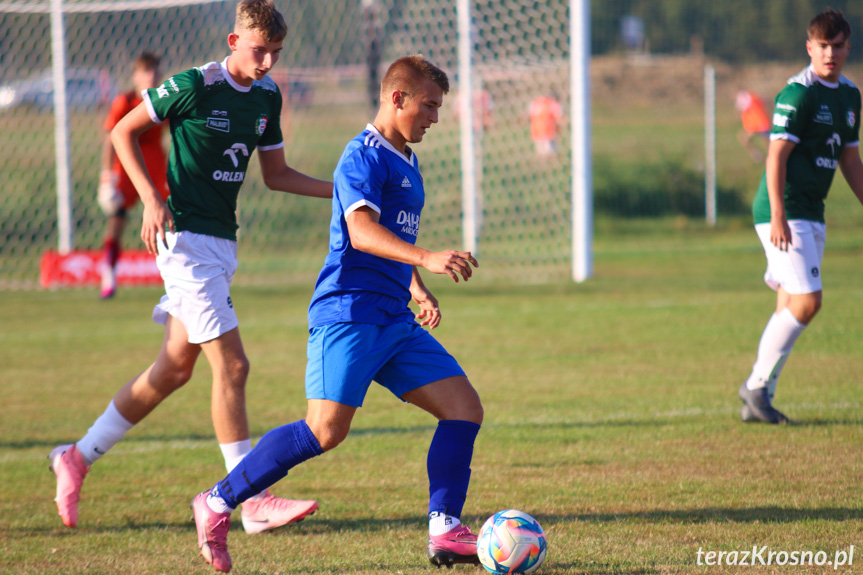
[755,220,827,295]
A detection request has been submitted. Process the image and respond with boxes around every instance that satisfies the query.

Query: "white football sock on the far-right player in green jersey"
[746,308,806,399]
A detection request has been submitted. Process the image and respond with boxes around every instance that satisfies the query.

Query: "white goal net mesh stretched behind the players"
[0,0,580,287]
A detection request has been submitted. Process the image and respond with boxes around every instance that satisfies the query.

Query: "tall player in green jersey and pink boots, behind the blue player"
[49,0,332,533]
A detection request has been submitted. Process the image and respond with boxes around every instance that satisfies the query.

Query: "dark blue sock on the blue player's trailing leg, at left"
[212,419,323,509]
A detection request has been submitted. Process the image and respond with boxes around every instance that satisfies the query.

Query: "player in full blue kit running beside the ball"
[192,56,483,572]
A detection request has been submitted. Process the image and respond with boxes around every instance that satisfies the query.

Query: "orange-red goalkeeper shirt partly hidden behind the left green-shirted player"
[105,90,168,204]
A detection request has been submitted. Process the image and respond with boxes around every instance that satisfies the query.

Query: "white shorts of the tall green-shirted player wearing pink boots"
[153,232,239,344]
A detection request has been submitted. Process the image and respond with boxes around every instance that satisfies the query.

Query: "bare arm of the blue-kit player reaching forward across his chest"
[345,206,479,283]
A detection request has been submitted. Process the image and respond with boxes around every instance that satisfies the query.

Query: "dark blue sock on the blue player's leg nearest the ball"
[427,420,480,517]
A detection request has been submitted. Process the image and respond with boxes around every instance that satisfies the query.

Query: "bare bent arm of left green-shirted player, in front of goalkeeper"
[111,103,174,255]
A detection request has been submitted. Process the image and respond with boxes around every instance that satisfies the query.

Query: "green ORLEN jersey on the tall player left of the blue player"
[144,58,284,240]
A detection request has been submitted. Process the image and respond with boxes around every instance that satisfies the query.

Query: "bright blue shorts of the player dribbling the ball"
[306,323,464,407]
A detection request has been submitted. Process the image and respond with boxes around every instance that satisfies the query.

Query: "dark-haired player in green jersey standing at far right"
[738,9,863,424]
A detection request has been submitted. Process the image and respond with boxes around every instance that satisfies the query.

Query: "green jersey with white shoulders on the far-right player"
[752,66,860,224]
